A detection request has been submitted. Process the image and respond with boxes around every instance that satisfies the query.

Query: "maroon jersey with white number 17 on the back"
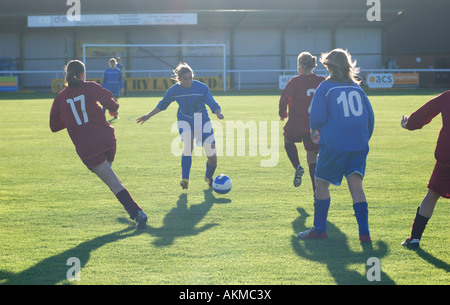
[50,82,119,160]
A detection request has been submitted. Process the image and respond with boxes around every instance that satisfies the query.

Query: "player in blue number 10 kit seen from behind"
[298,49,374,243]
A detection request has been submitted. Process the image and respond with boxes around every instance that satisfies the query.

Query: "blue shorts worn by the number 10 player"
[315,145,369,186]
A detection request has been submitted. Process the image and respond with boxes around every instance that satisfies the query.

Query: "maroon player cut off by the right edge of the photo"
[401,91,450,248]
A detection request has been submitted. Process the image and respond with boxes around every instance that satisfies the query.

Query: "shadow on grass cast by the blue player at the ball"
[147,190,231,247]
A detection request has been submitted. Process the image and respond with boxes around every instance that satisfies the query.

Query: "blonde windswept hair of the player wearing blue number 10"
[320,49,361,84]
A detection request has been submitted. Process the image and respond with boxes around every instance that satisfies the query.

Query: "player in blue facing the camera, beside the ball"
[136,63,224,189]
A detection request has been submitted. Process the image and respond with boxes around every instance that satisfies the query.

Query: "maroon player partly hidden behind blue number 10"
[279,52,325,191]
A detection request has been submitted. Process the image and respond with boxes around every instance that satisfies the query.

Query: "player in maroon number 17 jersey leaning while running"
[50,60,147,229]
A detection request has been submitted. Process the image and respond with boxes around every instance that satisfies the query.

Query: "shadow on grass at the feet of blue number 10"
[291,208,395,285]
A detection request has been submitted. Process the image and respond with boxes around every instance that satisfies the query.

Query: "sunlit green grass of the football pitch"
[0,90,450,285]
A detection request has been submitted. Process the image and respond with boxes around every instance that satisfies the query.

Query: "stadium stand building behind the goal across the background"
[0,0,450,91]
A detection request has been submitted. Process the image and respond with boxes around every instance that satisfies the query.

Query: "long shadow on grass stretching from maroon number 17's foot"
[0,226,143,285]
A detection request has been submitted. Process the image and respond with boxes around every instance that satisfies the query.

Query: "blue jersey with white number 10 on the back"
[310,80,374,152]
